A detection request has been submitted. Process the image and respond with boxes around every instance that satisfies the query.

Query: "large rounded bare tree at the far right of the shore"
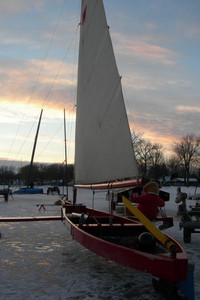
[173,134,200,185]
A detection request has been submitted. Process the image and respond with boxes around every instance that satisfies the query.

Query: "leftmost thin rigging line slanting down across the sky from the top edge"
[7,0,65,162]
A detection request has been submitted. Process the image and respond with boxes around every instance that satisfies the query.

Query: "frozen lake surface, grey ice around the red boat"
[0,187,200,300]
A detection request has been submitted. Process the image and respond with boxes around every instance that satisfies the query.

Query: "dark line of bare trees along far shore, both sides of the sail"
[0,133,200,185]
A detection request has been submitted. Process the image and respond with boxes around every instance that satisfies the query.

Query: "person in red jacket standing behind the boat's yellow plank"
[130,181,165,221]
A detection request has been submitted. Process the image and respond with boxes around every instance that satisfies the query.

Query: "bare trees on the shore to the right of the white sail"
[132,133,200,186]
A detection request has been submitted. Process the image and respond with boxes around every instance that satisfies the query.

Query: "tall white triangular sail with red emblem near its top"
[75,0,137,184]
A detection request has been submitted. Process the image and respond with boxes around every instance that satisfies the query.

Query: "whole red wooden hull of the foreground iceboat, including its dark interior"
[63,205,188,282]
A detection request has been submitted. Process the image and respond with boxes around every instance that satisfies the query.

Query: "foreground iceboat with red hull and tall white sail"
[62,0,188,282]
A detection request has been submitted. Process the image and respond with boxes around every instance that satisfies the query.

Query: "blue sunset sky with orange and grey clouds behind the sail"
[0,0,200,166]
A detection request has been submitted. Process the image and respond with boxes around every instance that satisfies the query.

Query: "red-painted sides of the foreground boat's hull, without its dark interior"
[64,208,188,282]
